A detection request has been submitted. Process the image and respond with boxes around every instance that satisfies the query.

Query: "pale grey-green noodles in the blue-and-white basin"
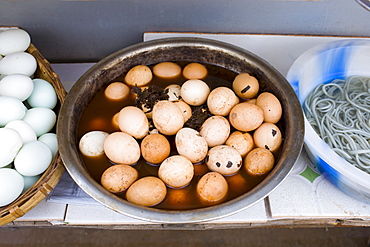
[303,76,370,174]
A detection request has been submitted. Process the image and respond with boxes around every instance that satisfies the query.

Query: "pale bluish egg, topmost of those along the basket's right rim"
[27,78,58,109]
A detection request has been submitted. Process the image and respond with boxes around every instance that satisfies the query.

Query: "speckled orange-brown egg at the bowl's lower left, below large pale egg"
[100,165,139,193]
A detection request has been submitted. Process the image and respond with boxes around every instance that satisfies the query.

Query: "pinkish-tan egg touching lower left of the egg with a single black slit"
[207,87,239,116]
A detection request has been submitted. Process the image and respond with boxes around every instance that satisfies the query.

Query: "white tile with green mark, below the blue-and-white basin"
[269,150,370,218]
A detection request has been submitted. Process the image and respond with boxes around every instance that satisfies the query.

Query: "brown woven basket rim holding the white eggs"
[0,44,66,226]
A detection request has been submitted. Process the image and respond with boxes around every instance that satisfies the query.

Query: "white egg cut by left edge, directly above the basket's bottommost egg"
[0,128,23,167]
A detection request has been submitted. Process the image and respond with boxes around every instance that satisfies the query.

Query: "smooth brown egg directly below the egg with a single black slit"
[229,102,263,132]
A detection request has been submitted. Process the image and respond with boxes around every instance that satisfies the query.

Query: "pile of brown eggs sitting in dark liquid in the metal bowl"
[79,62,283,206]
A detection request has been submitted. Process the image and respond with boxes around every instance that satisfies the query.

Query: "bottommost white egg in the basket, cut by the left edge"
[0,168,24,207]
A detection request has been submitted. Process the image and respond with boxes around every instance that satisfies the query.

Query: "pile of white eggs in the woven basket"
[0,29,58,207]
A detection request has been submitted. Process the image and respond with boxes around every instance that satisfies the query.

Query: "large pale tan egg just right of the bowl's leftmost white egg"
[104,132,140,165]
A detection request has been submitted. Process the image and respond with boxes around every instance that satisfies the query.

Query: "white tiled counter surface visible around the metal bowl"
[10,33,370,228]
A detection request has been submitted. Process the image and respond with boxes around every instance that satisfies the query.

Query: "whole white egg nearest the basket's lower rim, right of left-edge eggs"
[14,141,53,176]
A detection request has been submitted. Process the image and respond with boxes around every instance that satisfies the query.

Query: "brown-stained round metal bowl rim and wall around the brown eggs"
[57,38,304,223]
